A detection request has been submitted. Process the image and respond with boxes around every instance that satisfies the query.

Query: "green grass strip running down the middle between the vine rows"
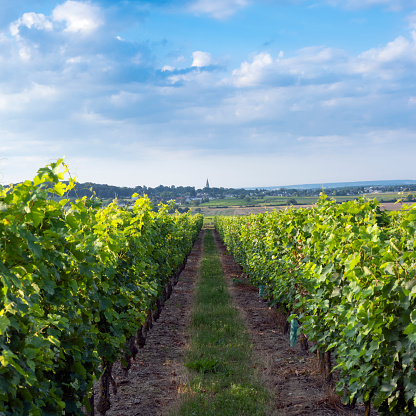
[175,229,271,416]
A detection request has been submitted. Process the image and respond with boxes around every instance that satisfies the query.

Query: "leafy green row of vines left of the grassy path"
[0,160,202,416]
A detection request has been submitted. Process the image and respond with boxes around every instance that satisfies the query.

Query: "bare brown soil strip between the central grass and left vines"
[96,230,204,416]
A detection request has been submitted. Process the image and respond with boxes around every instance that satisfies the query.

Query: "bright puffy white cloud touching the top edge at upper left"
[52,0,103,34]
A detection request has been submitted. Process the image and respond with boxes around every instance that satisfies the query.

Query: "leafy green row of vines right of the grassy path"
[215,195,416,416]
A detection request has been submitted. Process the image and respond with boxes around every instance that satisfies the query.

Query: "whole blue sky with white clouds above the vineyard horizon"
[0,0,416,188]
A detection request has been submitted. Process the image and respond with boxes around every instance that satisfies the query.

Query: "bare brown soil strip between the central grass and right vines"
[214,231,364,416]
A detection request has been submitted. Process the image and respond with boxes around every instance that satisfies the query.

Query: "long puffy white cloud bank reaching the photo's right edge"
[226,30,416,88]
